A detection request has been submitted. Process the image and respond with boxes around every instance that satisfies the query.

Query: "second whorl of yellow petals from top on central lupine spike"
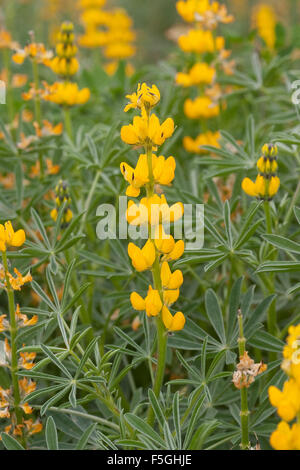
[121,113,174,146]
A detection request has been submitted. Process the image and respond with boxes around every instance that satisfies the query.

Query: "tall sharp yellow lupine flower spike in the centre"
[120,83,185,331]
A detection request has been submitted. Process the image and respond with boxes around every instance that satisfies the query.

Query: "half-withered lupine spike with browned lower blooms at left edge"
[0,221,42,443]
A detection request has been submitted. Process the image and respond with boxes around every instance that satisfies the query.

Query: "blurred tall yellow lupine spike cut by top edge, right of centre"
[176,0,234,153]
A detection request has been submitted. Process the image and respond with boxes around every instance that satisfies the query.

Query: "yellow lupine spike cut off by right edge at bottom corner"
[269,325,300,450]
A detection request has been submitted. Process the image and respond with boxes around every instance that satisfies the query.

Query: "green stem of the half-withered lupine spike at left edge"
[2,251,24,440]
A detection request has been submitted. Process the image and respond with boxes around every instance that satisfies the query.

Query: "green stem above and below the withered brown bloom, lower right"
[238,311,250,450]
